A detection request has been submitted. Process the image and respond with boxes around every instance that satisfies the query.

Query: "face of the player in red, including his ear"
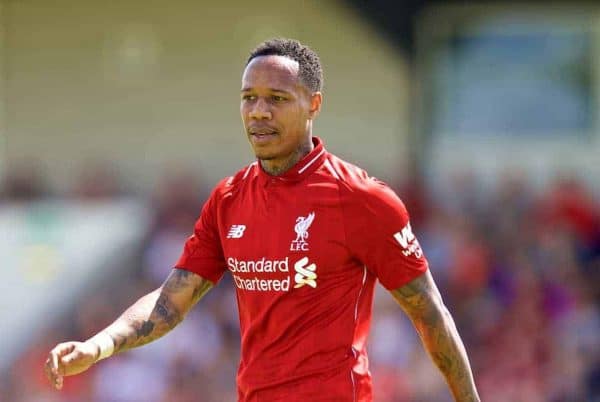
[240,56,321,167]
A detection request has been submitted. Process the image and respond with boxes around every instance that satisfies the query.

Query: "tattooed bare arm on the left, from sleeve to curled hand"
[45,269,212,389]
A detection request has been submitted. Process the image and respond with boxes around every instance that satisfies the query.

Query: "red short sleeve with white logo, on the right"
[344,178,428,290]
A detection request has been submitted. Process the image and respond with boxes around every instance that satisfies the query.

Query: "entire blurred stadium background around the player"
[0,0,600,402]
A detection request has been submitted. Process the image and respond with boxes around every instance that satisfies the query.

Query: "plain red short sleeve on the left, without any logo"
[175,186,226,284]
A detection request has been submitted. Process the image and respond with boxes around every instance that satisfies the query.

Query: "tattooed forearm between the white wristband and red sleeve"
[106,269,212,353]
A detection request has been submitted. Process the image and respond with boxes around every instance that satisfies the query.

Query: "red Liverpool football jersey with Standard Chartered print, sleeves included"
[175,138,427,402]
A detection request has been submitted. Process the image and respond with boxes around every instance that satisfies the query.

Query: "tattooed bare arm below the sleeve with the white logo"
[391,271,480,402]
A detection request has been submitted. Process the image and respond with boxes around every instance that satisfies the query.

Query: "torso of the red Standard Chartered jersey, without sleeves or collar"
[218,158,374,401]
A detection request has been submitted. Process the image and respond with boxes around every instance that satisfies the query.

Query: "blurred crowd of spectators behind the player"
[0,162,600,402]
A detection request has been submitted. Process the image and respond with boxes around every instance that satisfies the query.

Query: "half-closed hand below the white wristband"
[44,342,100,389]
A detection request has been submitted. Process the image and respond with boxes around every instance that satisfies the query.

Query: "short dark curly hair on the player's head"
[246,38,323,92]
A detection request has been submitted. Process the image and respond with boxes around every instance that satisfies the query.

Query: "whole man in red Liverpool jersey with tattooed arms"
[45,39,479,402]
